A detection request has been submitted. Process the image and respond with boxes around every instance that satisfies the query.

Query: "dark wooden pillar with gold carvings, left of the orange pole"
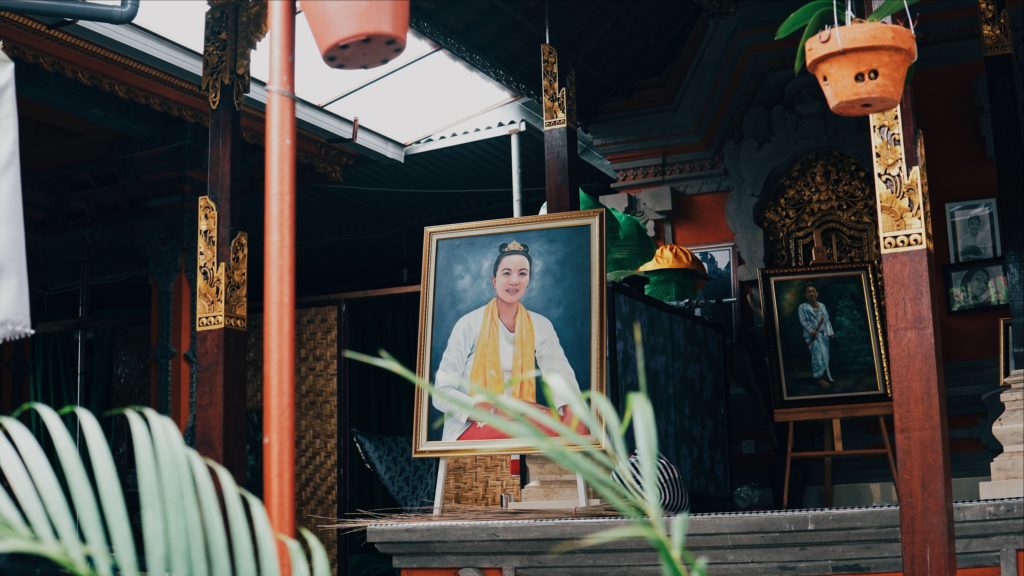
[195,0,266,478]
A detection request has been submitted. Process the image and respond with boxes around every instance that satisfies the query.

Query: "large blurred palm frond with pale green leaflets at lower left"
[0,403,331,576]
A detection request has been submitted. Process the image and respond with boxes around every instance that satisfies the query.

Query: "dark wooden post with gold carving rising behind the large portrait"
[541,44,580,214]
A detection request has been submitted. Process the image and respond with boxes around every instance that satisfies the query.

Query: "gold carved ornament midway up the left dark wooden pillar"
[196,196,249,332]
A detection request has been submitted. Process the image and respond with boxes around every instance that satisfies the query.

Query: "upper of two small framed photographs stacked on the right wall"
[946,198,1002,263]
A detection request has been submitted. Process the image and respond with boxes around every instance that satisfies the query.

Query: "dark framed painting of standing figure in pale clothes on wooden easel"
[760,263,892,408]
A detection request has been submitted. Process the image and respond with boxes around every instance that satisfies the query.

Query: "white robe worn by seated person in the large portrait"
[432,305,580,441]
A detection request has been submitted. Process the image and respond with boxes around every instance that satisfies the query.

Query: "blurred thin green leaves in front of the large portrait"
[344,342,707,576]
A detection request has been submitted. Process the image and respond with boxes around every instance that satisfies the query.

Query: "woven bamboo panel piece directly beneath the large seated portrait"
[443,456,519,506]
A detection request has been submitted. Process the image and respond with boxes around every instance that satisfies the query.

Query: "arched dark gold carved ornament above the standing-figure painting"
[759,152,879,266]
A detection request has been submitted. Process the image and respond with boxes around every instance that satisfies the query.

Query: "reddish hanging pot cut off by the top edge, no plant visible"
[300,0,409,70]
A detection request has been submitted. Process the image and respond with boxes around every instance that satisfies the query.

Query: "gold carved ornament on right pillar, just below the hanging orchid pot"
[870,107,928,254]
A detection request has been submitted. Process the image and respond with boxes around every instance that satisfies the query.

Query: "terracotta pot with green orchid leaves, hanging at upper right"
[804,22,918,116]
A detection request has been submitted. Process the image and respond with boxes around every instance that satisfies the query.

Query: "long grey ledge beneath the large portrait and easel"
[368,498,1024,576]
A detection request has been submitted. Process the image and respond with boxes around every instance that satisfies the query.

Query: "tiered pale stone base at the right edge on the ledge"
[978,370,1024,500]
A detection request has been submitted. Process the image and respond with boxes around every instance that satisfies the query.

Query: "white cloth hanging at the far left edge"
[0,50,32,342]
